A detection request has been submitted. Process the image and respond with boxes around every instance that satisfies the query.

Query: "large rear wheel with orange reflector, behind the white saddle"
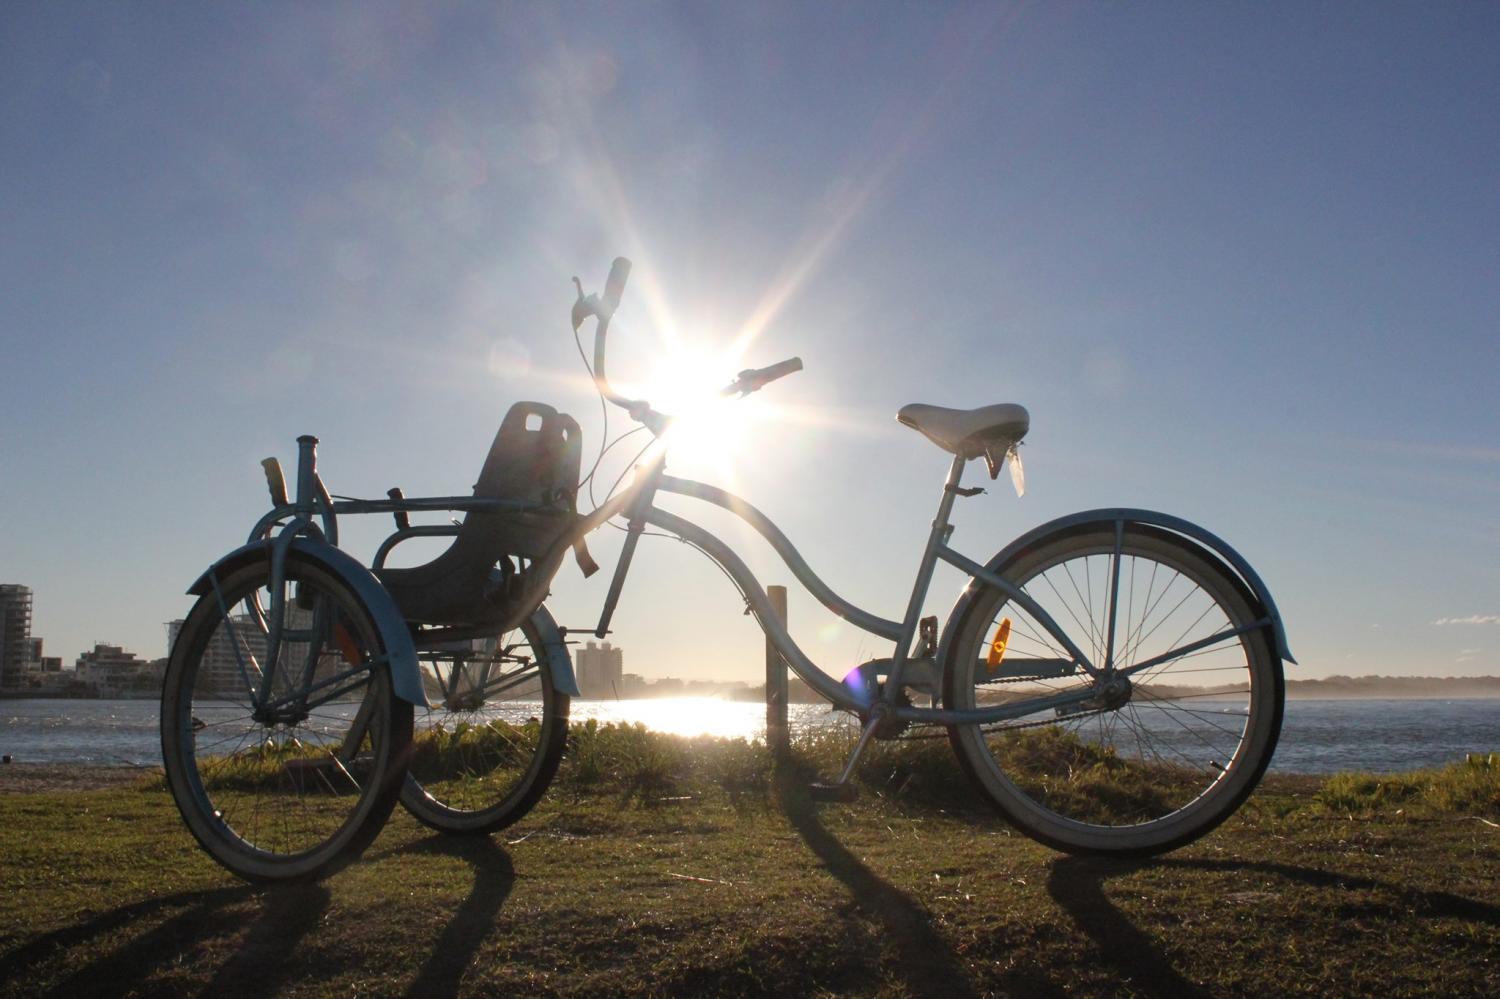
[944,522,1284,855]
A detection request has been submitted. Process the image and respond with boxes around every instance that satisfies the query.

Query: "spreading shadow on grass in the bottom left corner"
[0,885,329,998]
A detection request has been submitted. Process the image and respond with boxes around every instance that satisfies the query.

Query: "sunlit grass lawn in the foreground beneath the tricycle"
[0,726,1500,996]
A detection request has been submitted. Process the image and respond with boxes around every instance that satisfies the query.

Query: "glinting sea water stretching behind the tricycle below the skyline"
[0,698,1500,774]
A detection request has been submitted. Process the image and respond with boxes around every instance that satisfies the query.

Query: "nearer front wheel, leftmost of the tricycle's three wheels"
[162,552,411,882]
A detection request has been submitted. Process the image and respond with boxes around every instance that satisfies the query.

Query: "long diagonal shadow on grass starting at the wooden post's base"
[771,767,977,998]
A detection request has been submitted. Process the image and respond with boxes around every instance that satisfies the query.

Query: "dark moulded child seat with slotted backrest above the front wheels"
[375,402,584,624]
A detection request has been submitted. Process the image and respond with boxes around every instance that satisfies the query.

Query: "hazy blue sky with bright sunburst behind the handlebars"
[0,3,1500,683]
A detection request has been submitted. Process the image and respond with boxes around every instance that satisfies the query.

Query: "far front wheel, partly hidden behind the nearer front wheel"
[401,621,570,836]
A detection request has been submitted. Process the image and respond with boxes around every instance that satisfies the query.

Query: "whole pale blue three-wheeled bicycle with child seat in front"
[162,258,1296,881]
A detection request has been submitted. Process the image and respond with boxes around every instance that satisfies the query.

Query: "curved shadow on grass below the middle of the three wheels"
[366,836,516,996]
